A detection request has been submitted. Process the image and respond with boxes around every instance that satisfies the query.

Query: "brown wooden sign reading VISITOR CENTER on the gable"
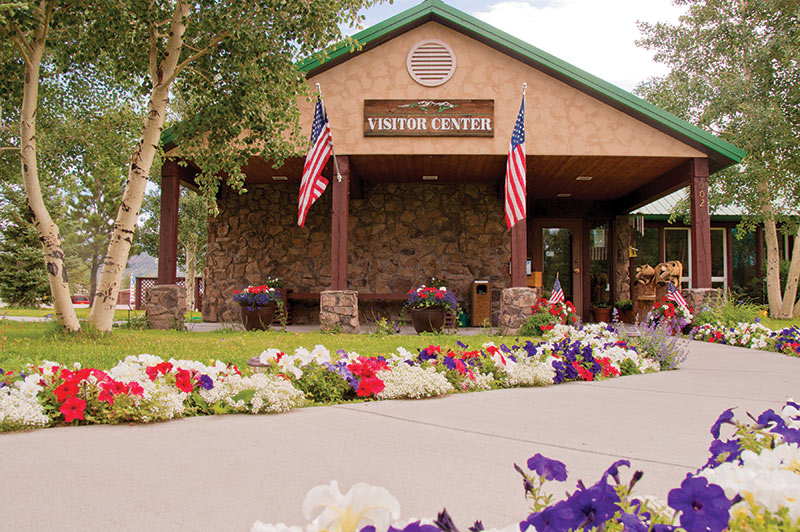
[364,99,494,137]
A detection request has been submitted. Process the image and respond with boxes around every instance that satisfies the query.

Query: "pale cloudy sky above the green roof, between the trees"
[348,0,685,91]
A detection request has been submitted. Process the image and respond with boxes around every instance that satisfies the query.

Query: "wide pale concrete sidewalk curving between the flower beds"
[0,342,800,532]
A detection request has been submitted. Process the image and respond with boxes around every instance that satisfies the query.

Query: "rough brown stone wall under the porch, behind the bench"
[203,183,511,323]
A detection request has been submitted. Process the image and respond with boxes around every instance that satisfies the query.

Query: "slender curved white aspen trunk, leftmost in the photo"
[20,19,81,331]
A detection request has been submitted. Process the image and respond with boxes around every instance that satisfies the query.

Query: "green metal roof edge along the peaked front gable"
[161,0,745,172]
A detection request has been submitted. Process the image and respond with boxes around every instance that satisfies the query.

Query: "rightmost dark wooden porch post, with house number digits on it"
[689,159,711,288]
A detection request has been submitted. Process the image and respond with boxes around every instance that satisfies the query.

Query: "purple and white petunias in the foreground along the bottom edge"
[251,401,800,532]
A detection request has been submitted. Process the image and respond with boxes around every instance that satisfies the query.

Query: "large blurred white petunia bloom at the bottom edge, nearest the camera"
[303,480,400,532]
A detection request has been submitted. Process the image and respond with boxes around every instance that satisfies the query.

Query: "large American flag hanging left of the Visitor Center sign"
[297,97,333,227]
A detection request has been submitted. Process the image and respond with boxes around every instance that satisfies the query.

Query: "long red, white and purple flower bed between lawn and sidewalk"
[0,325,661,430]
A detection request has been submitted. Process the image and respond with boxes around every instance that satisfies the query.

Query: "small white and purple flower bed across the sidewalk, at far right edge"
[692,322,800,356]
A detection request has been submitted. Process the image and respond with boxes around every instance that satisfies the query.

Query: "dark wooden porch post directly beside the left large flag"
[331,155,350,290]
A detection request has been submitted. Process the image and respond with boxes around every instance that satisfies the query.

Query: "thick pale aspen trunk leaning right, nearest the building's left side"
[89,0,189,332]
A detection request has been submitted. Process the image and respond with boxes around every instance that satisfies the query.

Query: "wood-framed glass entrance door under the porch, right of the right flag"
[531,219,583,316]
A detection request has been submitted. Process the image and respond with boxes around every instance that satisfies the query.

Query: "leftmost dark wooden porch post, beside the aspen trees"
[156,160,181,284]
